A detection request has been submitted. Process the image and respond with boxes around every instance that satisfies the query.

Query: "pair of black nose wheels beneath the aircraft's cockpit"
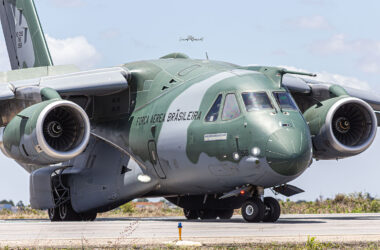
[241,197,281,222]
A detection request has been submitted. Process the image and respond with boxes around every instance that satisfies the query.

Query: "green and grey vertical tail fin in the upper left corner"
[0,0,53,69]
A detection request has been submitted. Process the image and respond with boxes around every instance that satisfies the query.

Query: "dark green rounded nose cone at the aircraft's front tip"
[266,129,312,176]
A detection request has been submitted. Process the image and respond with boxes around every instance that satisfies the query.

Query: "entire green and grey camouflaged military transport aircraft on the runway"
[0,0,380,222]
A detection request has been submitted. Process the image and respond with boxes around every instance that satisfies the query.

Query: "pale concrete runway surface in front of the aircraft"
[0,214,380,247]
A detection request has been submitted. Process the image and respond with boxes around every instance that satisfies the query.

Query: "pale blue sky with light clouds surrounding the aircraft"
[0,0,380,203]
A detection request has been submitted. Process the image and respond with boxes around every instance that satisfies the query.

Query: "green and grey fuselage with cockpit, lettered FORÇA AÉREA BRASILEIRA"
[95,54,312,196]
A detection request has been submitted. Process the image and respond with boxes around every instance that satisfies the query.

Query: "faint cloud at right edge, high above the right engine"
[311,34,380,73]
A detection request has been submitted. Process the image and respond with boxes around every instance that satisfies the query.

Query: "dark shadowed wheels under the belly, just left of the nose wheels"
[183,208,234,220]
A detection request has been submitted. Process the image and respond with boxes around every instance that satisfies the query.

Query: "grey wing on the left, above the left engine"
[0,66,130,127]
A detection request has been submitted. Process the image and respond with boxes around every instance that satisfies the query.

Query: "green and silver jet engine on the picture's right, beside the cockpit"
[304,96,377,159]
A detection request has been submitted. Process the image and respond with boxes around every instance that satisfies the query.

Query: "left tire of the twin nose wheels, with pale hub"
[241,198,265,222]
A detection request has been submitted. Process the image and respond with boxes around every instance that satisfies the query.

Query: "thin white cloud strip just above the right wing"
[280,66,370,90]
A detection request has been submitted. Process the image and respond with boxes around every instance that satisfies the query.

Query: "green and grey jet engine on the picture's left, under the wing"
[3,100,90,165]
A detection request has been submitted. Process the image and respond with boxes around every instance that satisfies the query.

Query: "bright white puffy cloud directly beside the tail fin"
[46,35,101,69]
